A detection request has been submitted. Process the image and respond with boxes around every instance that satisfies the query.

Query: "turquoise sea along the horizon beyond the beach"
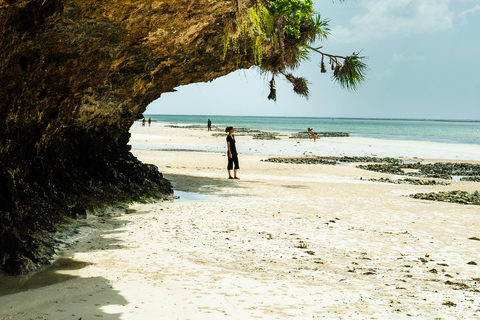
[145,115,480,145]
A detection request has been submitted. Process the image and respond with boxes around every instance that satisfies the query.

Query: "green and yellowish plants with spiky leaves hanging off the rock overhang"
[224,0,367,100]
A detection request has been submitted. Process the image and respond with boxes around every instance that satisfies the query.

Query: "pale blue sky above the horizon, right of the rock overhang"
[146,0,480,120]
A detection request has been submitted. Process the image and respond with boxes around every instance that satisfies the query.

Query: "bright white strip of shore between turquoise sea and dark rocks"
[130,122,480,161]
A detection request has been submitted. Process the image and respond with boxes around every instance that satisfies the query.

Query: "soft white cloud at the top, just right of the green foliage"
[329,0,454,42]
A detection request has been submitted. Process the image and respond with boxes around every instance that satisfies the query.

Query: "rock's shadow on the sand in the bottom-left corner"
[0,217,128,320]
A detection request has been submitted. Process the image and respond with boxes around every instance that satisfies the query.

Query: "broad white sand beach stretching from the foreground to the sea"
[0,123,480,320]
